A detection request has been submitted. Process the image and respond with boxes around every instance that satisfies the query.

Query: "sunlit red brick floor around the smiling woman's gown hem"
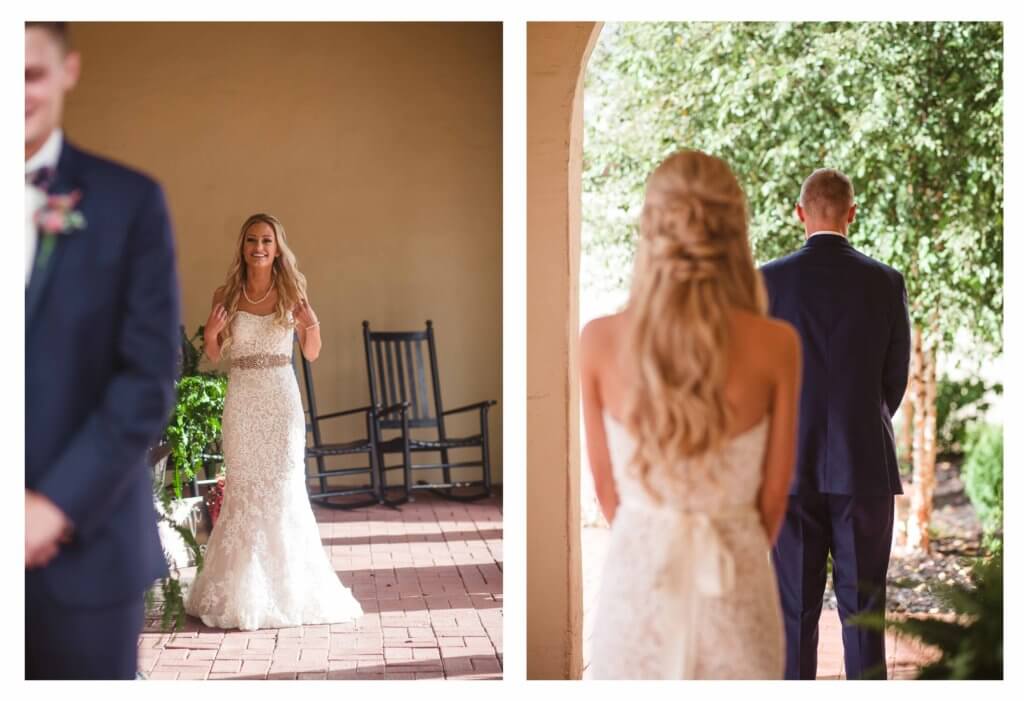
[139,494,503,680]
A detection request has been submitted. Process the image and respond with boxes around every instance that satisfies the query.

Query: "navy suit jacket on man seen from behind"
[761,234,910,495]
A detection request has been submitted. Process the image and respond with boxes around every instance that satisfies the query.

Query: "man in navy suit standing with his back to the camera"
[762,169,910,680]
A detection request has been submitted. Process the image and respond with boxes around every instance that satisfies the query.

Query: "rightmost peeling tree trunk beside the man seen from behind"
[907,327,936,553]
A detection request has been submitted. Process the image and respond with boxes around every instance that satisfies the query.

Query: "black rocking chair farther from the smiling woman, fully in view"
[362,320,498,503]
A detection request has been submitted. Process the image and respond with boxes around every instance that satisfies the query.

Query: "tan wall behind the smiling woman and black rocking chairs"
[66,23,502,481]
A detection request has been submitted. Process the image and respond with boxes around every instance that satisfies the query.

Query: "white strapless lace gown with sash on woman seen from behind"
[587,413,785,680]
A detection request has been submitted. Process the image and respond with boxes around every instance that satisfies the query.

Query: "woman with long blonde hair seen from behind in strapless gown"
[581,150,801,678]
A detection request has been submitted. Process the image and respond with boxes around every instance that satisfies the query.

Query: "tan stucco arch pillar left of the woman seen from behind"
[526,23,600,680]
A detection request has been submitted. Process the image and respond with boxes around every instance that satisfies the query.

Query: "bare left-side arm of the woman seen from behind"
[580,322,618,524]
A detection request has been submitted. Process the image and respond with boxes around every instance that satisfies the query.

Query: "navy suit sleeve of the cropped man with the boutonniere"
[38,183,179,541]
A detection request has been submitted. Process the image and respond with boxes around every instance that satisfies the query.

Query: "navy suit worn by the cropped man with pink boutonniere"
[25,141,179,678]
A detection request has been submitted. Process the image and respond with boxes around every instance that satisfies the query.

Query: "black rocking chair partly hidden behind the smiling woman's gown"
[298,335,403,509]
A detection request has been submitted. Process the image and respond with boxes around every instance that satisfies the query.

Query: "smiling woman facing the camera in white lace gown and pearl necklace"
[185,214,362,630]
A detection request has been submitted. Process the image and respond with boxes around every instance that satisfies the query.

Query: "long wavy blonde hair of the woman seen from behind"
[626,150,767,499]
